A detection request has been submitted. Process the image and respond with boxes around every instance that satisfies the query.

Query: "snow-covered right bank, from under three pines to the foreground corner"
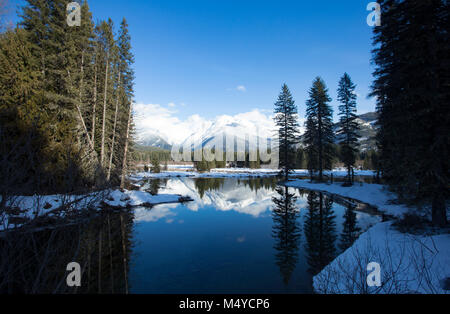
[285,180,450,294]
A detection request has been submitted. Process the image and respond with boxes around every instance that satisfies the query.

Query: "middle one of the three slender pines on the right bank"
[304,77,334,181]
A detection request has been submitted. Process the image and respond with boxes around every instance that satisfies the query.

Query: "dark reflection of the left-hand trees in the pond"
[0,210,133,294]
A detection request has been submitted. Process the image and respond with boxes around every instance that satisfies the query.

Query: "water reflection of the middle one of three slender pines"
[304,192,336,275]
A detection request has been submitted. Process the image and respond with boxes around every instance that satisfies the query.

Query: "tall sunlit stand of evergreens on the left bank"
[0,0,134,193]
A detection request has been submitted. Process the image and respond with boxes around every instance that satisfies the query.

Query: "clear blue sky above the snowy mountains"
[9,0,375,119]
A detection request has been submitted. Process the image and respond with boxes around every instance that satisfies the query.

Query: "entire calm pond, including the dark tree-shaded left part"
[0,178,381,294]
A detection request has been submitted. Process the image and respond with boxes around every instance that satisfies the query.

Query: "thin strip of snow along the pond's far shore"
[130,166,375,181]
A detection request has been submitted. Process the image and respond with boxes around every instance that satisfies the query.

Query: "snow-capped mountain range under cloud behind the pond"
[136,105,378,150]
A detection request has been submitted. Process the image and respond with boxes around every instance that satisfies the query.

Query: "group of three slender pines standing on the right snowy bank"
[274,73,359,185]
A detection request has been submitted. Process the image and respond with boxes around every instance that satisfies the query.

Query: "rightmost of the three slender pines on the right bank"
[337,73,359,185]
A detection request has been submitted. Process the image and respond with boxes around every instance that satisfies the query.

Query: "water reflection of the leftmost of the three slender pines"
[272,187,300,286]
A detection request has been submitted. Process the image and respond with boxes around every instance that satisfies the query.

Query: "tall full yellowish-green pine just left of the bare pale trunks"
[18,0,93,191]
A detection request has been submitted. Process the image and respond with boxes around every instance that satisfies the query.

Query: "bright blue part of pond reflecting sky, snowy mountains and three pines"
[128,178,380,293]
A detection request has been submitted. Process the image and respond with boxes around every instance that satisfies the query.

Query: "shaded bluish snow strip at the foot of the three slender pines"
[285,180,410,217]
